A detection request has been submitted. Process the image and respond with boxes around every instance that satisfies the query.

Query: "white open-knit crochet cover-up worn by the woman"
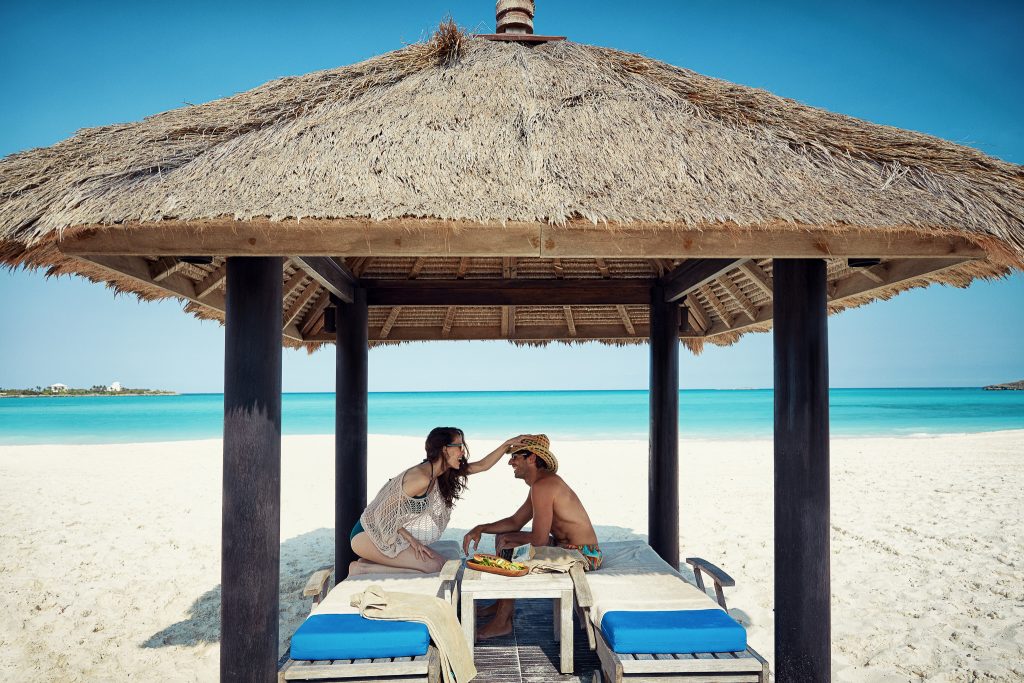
[359,470,452,557]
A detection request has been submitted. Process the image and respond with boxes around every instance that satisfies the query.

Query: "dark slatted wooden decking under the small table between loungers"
[474,600,600,683]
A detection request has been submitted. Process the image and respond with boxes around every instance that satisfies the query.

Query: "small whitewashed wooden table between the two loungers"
[459,567,572,674]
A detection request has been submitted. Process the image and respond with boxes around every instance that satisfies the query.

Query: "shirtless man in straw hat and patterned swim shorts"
[462,434,602,640]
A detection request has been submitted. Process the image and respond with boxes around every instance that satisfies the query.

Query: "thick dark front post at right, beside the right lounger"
[773,259,831,683]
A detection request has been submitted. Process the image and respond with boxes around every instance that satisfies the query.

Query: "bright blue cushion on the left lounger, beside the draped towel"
[292,614,430,659]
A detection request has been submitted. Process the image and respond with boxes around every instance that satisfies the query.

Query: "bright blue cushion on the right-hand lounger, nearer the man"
[601,609,746,654]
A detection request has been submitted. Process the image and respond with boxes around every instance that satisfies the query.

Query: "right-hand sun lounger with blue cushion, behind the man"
[581,541,768,683]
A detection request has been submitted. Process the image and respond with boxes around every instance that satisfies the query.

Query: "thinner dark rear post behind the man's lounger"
[647,287,679,567]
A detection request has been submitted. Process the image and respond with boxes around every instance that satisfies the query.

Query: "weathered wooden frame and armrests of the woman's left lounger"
[278,560,462,683]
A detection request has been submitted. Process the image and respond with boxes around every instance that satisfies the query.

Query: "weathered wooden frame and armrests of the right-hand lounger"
[579,557,768,683]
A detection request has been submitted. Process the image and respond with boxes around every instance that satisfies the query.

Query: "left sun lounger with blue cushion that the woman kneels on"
[278,541,462,683]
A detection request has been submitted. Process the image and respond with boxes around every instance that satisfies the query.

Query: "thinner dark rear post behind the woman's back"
[334,287,369,582]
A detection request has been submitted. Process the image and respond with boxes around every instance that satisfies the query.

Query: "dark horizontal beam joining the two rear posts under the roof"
[360,280,652,306]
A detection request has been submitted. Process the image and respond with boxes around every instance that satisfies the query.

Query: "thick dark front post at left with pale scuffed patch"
[220,257,283,683]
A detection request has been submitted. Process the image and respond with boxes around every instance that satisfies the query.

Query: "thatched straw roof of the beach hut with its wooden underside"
[0,25,1024,350]
